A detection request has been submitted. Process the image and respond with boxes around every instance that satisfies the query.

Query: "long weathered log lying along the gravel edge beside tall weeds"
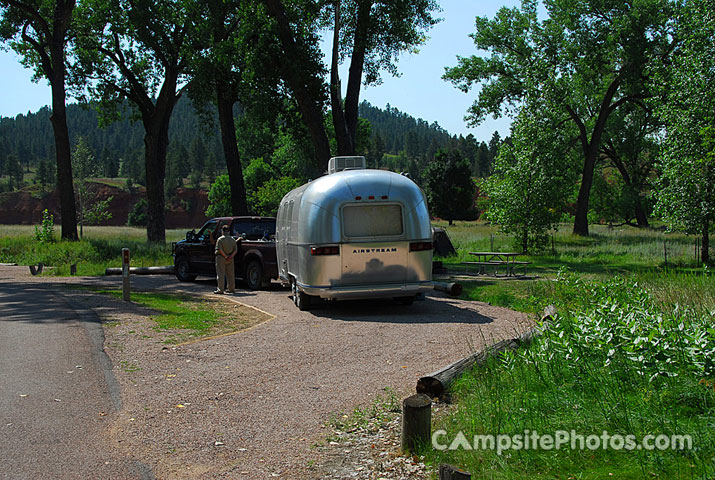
[416,305,556,398]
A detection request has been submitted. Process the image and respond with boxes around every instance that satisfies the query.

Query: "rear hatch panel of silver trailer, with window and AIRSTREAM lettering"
[340,203,409,285]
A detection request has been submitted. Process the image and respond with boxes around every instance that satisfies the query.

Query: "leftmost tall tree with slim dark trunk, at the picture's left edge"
[0,0,77,240]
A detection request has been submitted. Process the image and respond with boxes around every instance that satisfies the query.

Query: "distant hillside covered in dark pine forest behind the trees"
[0,97,499,183]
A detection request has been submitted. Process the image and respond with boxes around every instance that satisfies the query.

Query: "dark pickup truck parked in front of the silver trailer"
[171,217,278,290]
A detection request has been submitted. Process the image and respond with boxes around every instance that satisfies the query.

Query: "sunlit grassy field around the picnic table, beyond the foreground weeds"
[437,222,715,313]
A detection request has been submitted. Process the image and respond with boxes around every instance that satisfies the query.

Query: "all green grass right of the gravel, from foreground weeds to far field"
[421,223,715,479]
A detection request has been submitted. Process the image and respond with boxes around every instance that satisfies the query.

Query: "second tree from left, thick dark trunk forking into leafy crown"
[77,0,207,243]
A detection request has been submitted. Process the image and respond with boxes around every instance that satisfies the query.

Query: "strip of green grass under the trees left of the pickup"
[0,225,186,276]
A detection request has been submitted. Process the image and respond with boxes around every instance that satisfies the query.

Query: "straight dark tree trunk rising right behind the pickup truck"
[216,80,248,215]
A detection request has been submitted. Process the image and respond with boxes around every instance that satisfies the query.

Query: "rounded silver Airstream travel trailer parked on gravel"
[276,157,432,310]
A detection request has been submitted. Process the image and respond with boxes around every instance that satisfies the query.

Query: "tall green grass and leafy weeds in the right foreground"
[422,277,715,479]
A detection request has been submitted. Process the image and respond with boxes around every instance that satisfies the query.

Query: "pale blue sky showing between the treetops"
[0,0,519,141]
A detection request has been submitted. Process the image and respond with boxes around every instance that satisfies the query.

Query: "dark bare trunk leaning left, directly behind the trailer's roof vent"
[265,0,330,174]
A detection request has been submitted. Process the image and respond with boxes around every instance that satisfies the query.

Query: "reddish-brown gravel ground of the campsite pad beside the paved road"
[0,267,531,479]
